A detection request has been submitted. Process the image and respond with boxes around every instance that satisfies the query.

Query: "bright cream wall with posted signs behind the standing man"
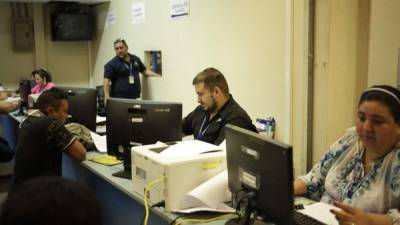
[92,0,291,142]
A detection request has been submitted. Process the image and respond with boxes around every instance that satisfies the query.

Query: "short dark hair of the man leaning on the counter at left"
[36,88,68,114]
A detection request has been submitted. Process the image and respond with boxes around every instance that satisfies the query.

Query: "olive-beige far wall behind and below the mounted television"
[0,3,90,88]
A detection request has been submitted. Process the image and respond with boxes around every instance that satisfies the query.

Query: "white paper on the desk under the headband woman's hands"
[298,202,340,225]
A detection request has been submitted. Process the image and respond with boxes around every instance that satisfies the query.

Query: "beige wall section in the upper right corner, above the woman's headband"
[368,0,400,86]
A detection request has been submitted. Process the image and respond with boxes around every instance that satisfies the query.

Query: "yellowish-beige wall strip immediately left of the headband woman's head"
[313,0,370,163]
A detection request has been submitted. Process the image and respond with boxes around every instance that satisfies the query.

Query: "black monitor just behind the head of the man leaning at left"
[58,87,97,131]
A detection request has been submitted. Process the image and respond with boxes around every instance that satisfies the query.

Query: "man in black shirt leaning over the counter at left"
[14,88,86,186]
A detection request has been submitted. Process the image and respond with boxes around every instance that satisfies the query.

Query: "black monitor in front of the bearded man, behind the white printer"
[106,98,182,155]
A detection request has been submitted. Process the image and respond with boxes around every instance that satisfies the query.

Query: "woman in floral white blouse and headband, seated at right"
[294,85,400,225]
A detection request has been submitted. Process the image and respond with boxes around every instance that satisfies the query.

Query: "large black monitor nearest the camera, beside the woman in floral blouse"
[225,125,293,225]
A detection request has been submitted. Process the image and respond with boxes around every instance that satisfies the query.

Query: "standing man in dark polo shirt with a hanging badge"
[103,39,160,102]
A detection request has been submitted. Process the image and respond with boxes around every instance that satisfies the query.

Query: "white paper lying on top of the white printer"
[160,140,222,158]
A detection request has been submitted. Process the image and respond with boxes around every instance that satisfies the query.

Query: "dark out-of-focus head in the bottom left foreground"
[0,177,102,225]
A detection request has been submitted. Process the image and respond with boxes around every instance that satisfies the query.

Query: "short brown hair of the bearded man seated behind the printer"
[192,67,229,96]
